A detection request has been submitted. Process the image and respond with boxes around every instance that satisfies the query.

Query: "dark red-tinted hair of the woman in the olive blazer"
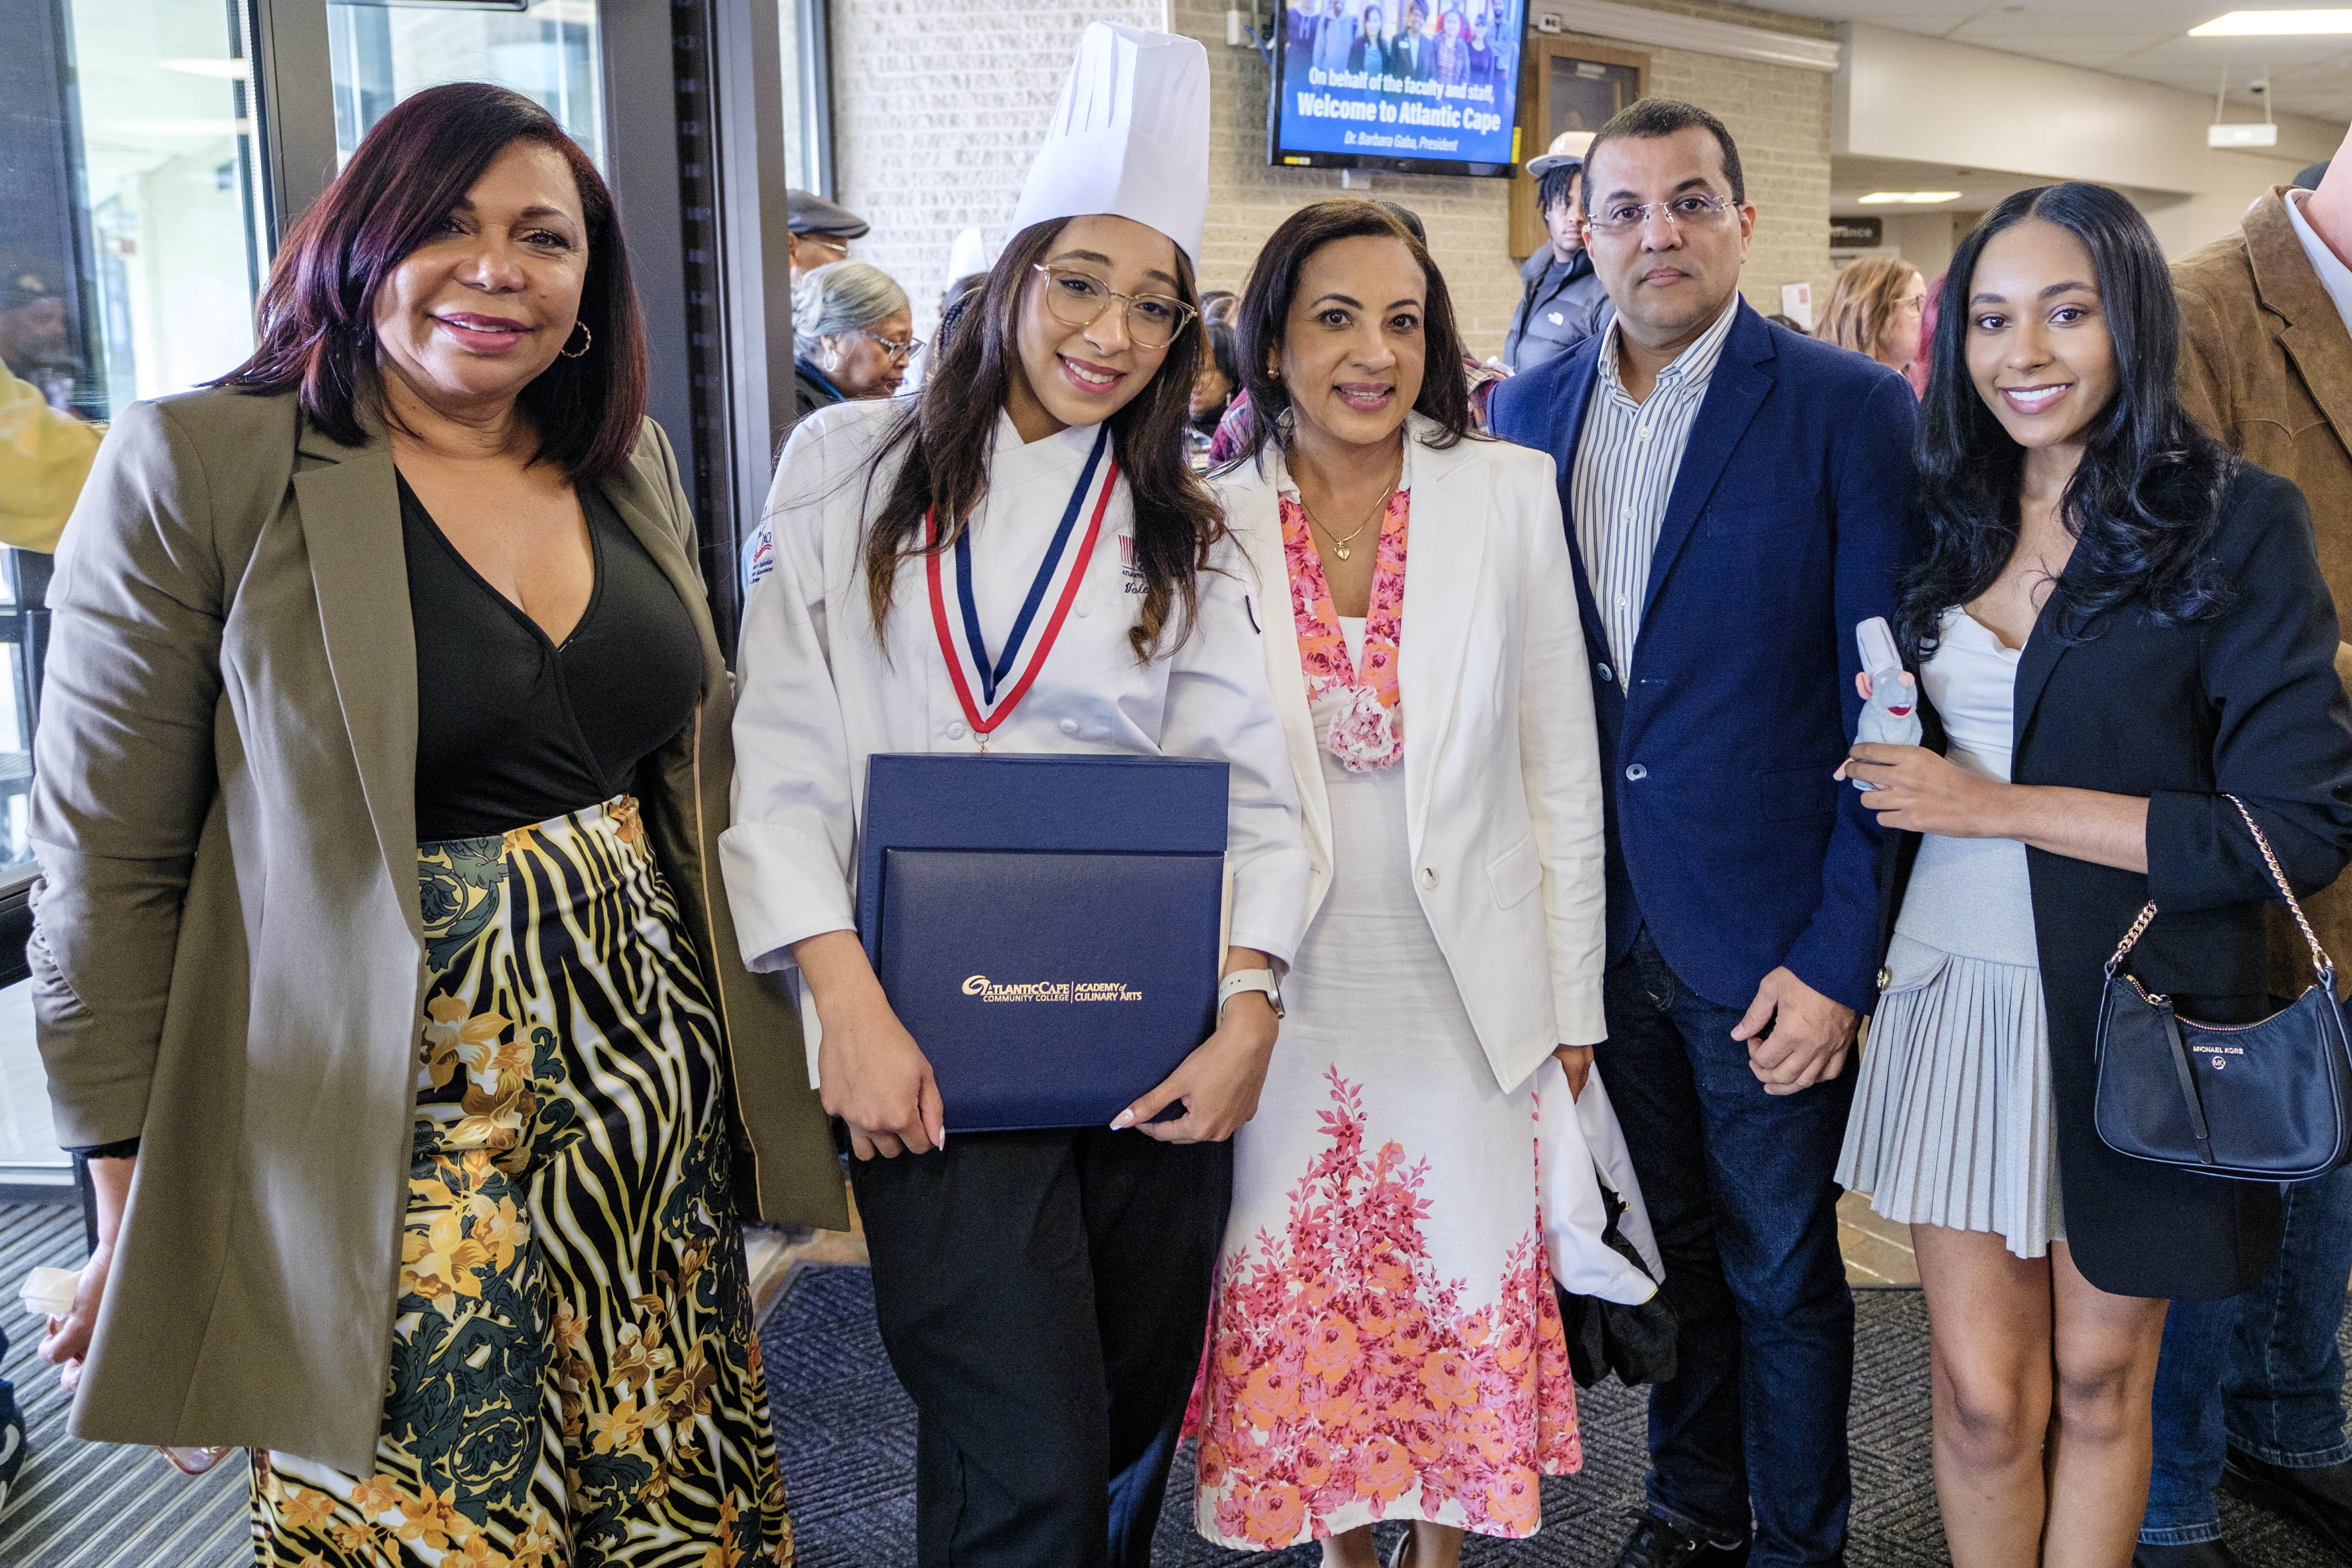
[218,82,645,479]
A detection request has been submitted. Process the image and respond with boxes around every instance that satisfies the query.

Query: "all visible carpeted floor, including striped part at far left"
[0,1204,2333,1568]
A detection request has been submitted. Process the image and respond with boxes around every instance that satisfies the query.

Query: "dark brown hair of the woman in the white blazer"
[1232,197,1470,463]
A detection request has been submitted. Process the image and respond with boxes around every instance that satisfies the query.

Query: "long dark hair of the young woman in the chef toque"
[866,218,1225,658]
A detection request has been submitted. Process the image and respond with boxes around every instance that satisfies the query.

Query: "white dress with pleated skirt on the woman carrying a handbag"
[1837,607,2065,1258]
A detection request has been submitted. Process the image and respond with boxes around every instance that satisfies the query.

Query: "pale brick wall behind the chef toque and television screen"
[814,0,1832,355]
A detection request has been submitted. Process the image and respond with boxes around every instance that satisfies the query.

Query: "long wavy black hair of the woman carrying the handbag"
[1896,181,2237,658]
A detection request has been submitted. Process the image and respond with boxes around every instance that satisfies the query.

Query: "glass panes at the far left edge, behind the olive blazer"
[0,0,266,1182]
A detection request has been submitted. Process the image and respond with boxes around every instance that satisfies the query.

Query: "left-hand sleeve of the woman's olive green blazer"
[26,402,223,1147]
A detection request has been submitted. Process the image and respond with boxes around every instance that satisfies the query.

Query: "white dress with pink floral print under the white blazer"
[1195,451,1583,1549]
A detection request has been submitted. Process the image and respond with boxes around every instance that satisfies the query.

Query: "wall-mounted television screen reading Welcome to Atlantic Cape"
[1265,0,1526,176]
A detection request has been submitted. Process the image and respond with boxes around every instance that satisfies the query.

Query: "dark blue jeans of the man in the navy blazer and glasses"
[1597,928,1853,1568]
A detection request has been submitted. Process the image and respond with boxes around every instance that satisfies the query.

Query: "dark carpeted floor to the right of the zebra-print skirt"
[760,1265,2338,1568]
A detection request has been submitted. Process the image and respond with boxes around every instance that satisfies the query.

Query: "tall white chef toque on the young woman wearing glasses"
[1011,21,1209,265]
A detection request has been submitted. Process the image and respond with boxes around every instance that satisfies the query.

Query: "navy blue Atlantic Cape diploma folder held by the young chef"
[859,752,1225,1133]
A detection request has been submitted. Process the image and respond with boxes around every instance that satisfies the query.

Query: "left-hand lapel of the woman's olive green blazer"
[294,419,423,945]
